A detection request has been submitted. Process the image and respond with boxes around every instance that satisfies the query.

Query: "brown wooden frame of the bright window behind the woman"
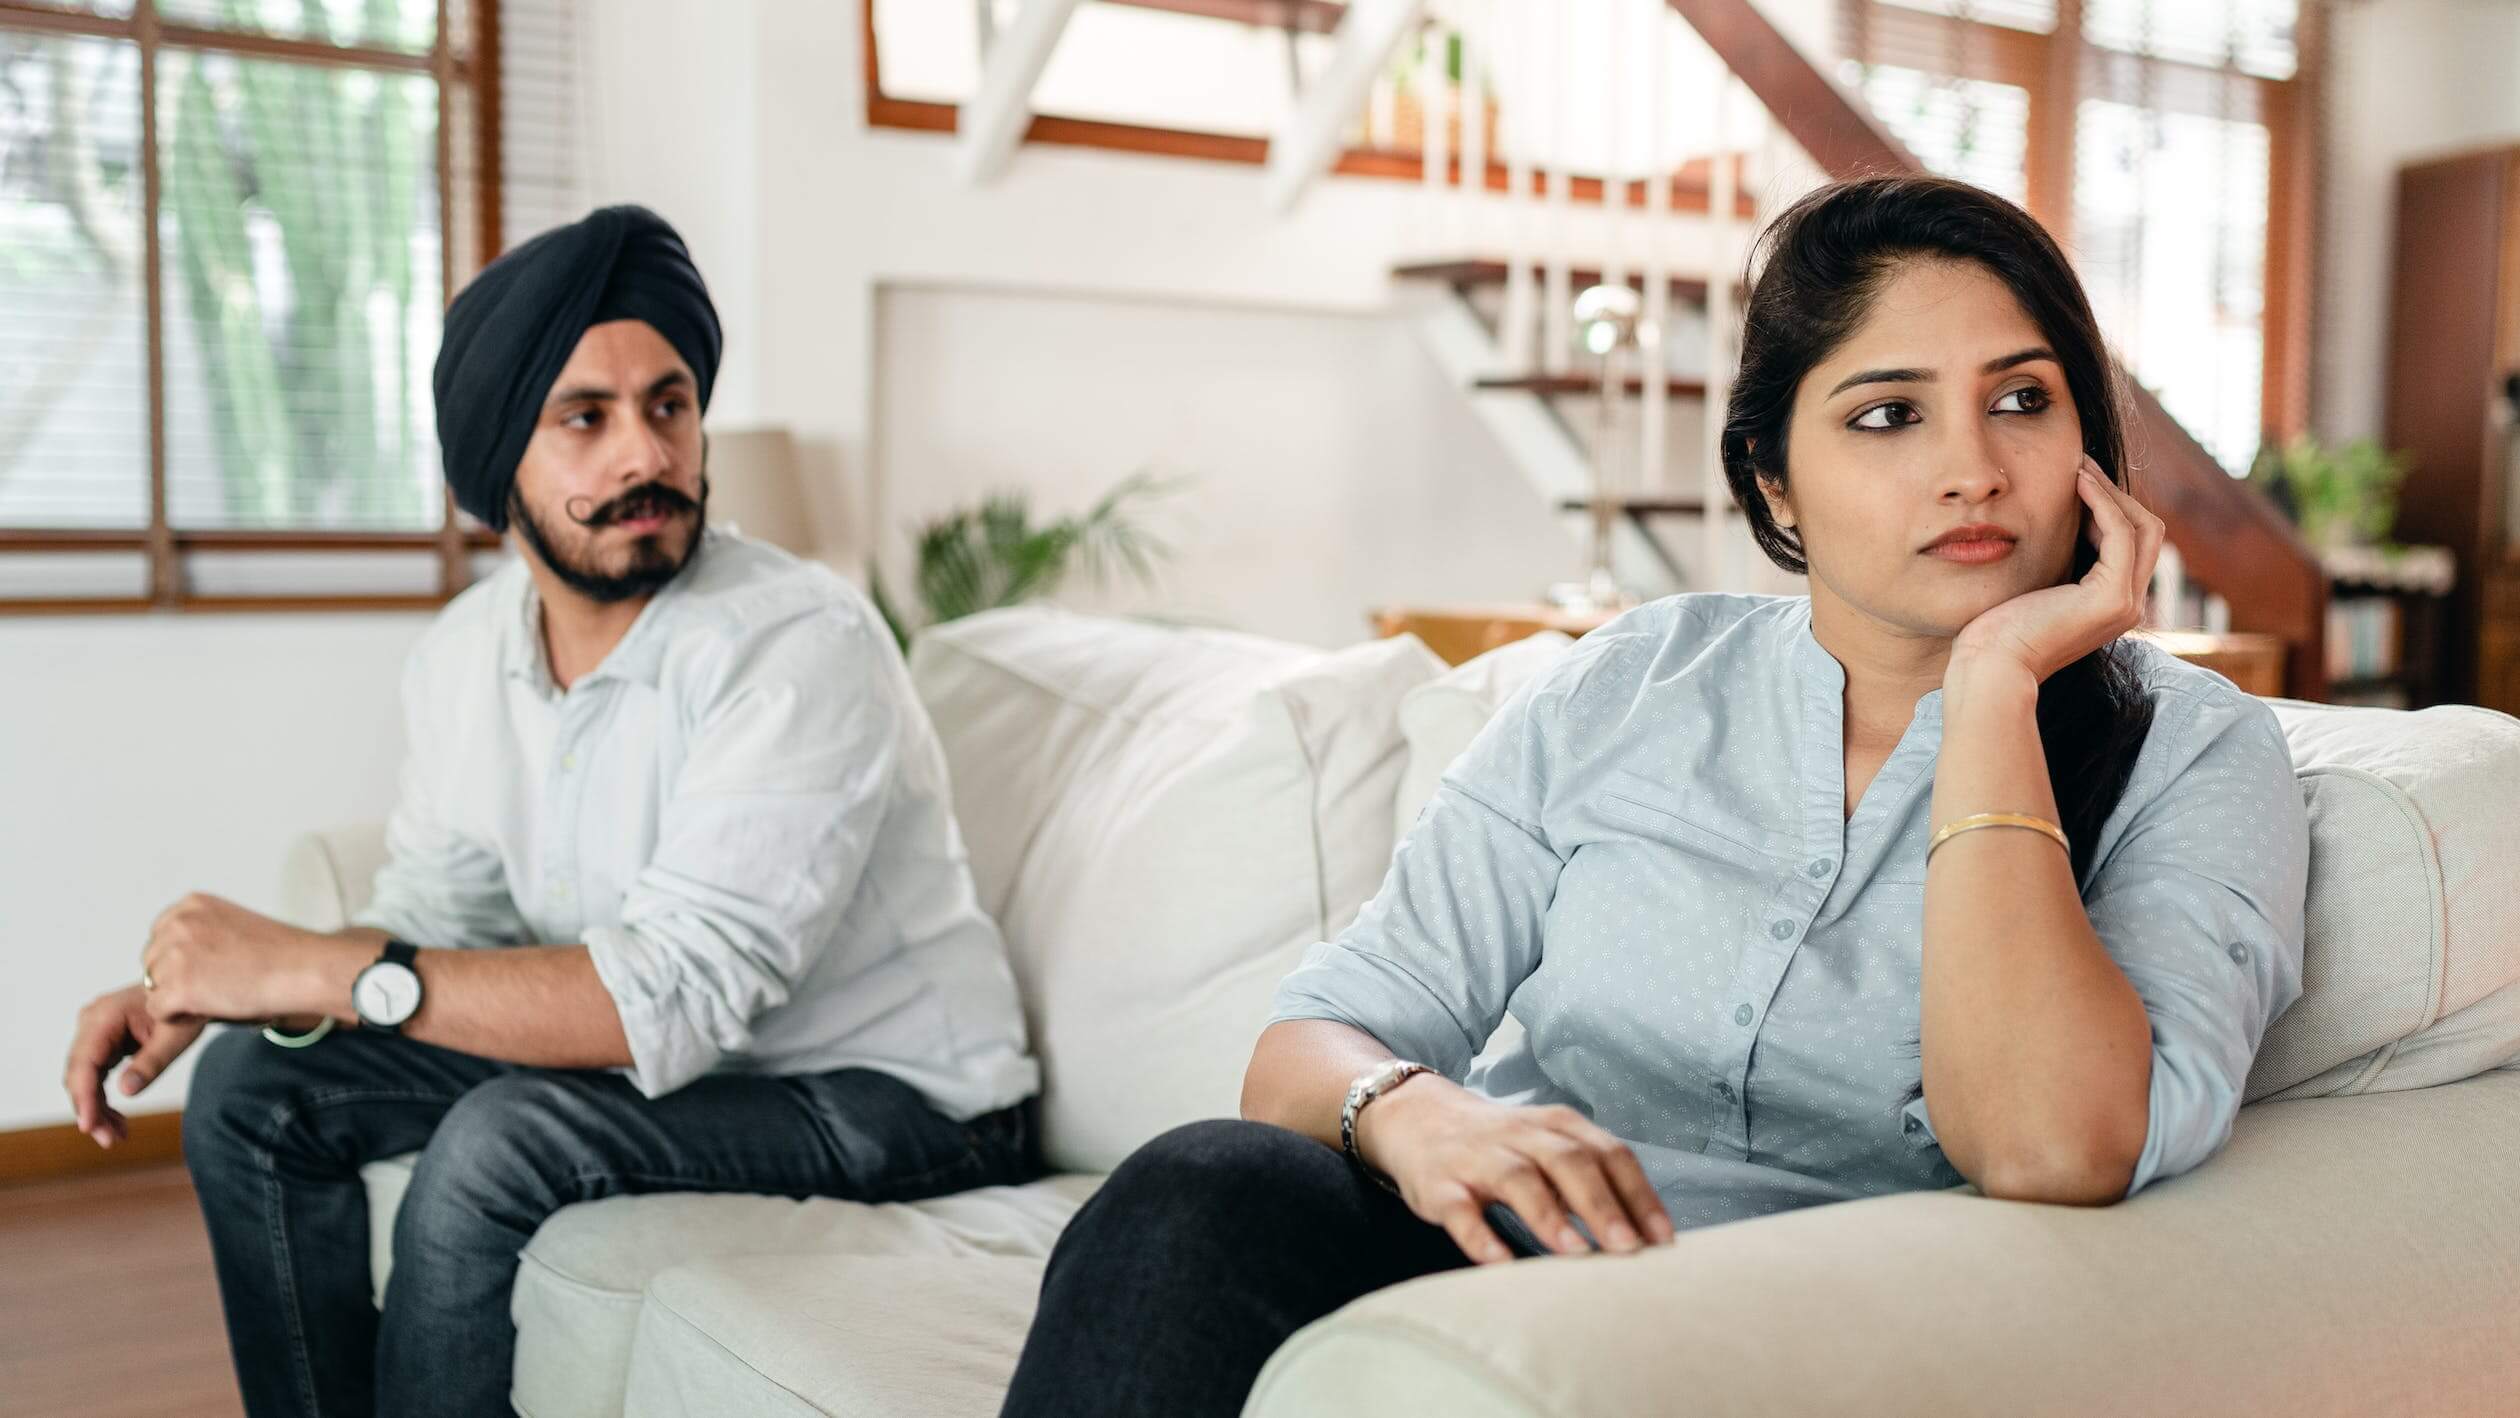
[1857,0,2328,441]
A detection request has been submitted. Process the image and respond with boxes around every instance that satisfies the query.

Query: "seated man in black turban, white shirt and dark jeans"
[66,207,1041,1415]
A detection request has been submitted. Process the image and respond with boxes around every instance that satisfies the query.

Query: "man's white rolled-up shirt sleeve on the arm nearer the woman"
[585,612,905,1098]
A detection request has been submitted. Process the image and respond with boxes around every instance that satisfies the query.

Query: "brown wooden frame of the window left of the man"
[0,0,501,615]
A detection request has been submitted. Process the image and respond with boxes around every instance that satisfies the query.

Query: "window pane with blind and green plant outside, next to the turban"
[156,48,446,531]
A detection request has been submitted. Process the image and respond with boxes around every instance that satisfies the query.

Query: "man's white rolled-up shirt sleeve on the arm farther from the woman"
[350,642,529,950]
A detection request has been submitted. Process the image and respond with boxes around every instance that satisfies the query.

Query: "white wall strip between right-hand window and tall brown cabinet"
[2311,0,2520,438]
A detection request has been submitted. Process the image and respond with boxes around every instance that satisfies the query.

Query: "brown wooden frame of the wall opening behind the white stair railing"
[857,0,1759,222]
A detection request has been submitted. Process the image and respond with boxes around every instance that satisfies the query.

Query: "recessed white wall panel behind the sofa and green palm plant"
[872,285,1580,645]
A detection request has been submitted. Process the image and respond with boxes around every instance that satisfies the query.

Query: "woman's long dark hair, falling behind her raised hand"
[1724,176,2152,882]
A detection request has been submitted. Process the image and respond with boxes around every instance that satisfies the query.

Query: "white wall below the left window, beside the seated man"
[0,615,426,1128]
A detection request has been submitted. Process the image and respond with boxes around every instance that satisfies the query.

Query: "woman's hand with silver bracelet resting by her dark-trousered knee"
[1356,1073,1673,1264]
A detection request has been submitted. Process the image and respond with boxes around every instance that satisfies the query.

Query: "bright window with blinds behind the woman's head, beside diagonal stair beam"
[1840,0,2318,476]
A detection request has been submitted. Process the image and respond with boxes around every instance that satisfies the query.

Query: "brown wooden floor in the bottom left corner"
[0,1166,244,1418]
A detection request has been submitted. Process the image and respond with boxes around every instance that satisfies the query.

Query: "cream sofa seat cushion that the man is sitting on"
[363,1156,1101,1418]
